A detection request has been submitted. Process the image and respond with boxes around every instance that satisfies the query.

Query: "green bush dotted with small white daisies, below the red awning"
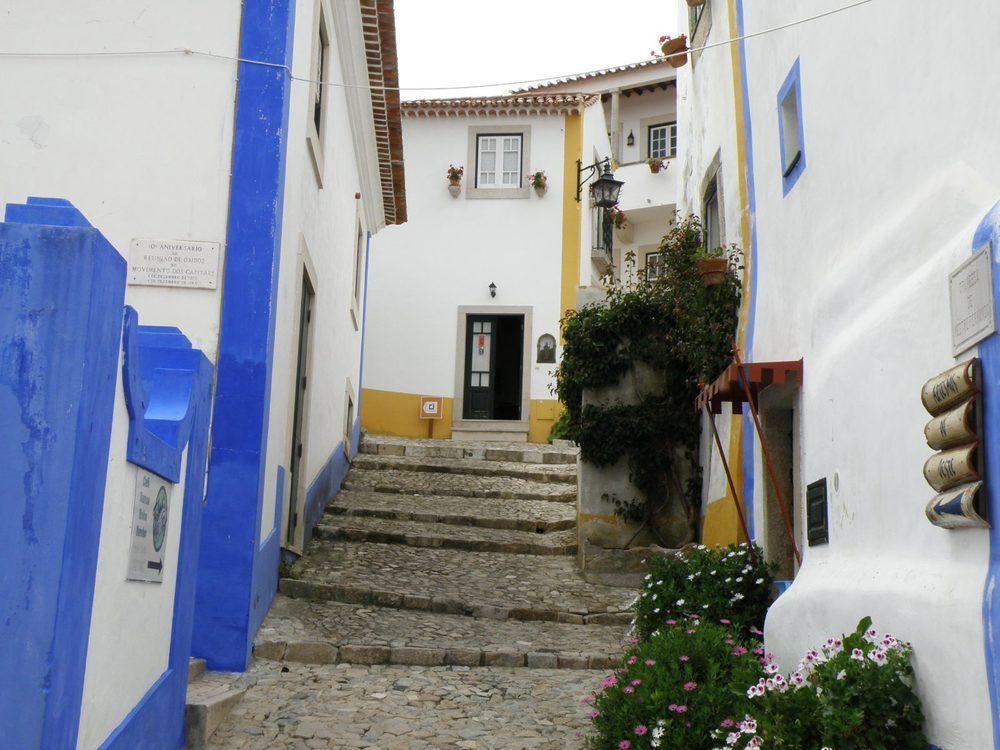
[636,544,773,638]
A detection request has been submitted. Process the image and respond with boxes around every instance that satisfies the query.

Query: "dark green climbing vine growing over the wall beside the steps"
[556,216,743,539]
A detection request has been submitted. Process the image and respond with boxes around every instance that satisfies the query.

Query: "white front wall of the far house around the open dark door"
[365,112,572,406]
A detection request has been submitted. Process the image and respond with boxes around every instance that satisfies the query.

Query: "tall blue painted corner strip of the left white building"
[193,0,295,670]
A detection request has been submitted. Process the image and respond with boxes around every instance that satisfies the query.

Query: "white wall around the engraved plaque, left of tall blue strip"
[0,0,240,361]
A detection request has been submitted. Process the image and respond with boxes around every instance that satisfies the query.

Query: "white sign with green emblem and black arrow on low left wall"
[126,469,174,583]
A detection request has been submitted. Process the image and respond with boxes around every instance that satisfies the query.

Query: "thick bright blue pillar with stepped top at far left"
[0,198,125,748]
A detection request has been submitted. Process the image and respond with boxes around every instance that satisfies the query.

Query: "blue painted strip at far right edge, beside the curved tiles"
[972,203,1000,750]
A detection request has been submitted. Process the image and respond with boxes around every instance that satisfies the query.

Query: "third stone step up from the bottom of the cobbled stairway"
[313,516,577,555]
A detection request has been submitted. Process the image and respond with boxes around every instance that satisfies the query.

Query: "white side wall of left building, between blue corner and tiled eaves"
[260,0,378,541]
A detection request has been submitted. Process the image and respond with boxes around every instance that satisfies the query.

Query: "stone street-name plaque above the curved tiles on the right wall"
[948,246,997,356]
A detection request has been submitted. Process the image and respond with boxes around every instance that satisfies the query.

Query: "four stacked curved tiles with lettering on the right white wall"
[920,358,989,529]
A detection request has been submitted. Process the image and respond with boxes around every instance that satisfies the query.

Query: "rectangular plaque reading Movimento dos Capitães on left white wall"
[128,240,221,289]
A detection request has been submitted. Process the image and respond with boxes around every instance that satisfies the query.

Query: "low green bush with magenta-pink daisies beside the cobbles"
[584,615,764,750]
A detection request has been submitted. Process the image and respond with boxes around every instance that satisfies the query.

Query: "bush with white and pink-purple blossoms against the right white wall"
[716,617,927,750]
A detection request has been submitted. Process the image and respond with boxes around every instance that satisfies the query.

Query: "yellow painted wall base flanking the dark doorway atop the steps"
[361,388,563,443]
